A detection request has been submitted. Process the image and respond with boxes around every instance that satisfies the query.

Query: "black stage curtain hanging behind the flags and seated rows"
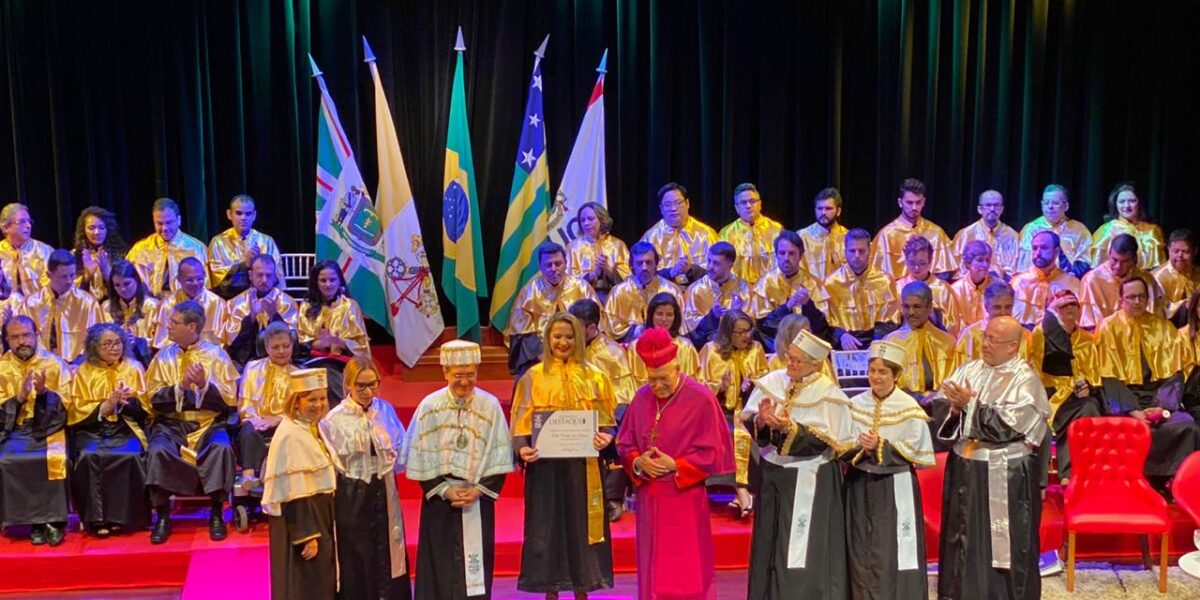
[0,0,1200,323]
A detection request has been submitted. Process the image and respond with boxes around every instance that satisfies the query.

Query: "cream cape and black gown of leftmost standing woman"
[263,416,338,600]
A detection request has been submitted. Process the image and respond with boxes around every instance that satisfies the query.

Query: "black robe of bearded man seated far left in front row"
[0,390,67,527]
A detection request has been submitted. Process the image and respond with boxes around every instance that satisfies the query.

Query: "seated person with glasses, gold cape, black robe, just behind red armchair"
[1096,276,1200,490]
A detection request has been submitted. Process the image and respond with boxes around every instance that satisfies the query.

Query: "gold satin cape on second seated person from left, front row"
[64,358,151,450]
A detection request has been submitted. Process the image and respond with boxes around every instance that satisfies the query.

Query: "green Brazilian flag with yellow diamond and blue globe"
[442,28,487,342]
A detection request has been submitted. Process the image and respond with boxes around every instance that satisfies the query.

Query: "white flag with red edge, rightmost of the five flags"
[546,50,608,246]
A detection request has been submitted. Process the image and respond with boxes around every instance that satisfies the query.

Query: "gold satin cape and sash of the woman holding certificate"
[509,359,617,544]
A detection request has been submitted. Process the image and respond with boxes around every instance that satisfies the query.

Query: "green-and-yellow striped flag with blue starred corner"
[492,36,550,331]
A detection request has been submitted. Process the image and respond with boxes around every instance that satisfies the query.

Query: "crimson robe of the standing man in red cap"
[617,377,733,600]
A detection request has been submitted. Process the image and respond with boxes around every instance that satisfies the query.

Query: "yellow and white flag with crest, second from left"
[362,36,445,367]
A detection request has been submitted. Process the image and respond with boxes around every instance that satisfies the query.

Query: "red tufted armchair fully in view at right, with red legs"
[1064,416,1171,593]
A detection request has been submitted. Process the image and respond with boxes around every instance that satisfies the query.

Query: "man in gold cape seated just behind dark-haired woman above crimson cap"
[604,241,686,342]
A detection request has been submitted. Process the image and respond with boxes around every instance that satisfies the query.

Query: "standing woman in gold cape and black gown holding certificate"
[510,312,616,600]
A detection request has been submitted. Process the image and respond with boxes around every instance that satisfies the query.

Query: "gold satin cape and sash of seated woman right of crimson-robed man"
[700,342,767,486]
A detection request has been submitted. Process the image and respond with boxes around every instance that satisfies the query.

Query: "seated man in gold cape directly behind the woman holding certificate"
[504,241,607,379]
